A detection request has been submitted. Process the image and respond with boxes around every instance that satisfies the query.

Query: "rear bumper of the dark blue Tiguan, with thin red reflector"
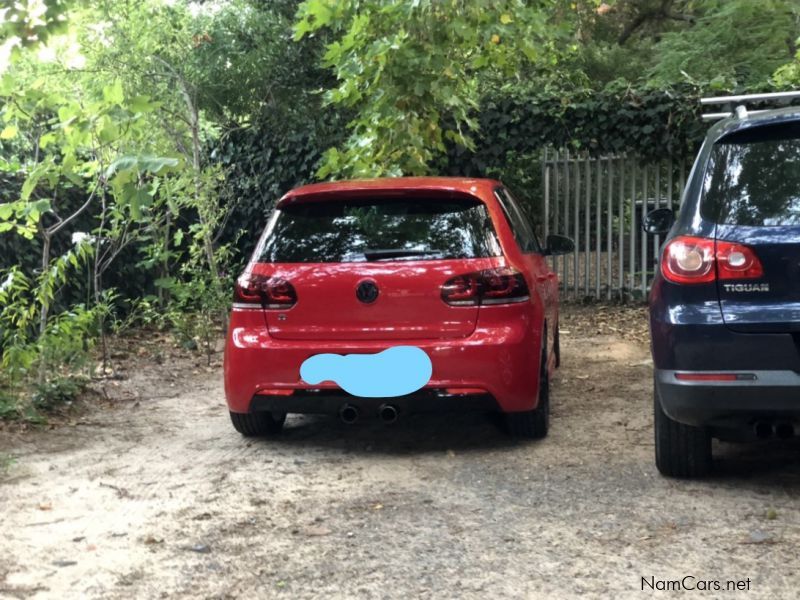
[655,369,800,427]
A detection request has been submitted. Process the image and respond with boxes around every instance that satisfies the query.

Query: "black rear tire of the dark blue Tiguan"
[653,383,712,479]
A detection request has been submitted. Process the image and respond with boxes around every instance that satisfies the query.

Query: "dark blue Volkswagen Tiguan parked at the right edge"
[644,107,800,477]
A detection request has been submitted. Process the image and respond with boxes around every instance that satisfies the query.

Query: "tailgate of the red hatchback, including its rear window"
[253,192,504,340]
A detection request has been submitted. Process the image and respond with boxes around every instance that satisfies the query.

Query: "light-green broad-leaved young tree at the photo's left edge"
[0,32,178,392]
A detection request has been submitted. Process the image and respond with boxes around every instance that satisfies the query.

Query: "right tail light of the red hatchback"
[442,267,530,306]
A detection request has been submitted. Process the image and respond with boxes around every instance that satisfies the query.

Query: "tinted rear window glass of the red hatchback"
[259,198,501,263]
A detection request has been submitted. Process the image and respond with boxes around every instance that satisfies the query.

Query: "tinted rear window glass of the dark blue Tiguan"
[703,123,800,227]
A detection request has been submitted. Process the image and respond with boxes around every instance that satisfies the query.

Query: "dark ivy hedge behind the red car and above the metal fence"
[211,86,708,256]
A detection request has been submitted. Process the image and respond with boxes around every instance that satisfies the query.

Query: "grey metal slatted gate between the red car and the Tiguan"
[542,150,686,300]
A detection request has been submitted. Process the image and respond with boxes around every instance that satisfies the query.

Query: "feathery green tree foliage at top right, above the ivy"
[565,0,800,90]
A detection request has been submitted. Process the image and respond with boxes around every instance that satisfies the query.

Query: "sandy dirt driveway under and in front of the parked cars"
[0,307,800,598]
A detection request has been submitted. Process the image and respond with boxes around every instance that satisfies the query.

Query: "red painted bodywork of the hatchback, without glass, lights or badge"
[224,177,558,413]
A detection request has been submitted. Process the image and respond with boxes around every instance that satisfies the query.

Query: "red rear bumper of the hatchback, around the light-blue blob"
[224,305,541,413]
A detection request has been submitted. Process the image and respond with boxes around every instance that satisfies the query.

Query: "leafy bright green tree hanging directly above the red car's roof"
[295,0,564,177]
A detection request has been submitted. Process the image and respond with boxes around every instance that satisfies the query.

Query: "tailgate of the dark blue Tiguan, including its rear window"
[703,122,800,332]
